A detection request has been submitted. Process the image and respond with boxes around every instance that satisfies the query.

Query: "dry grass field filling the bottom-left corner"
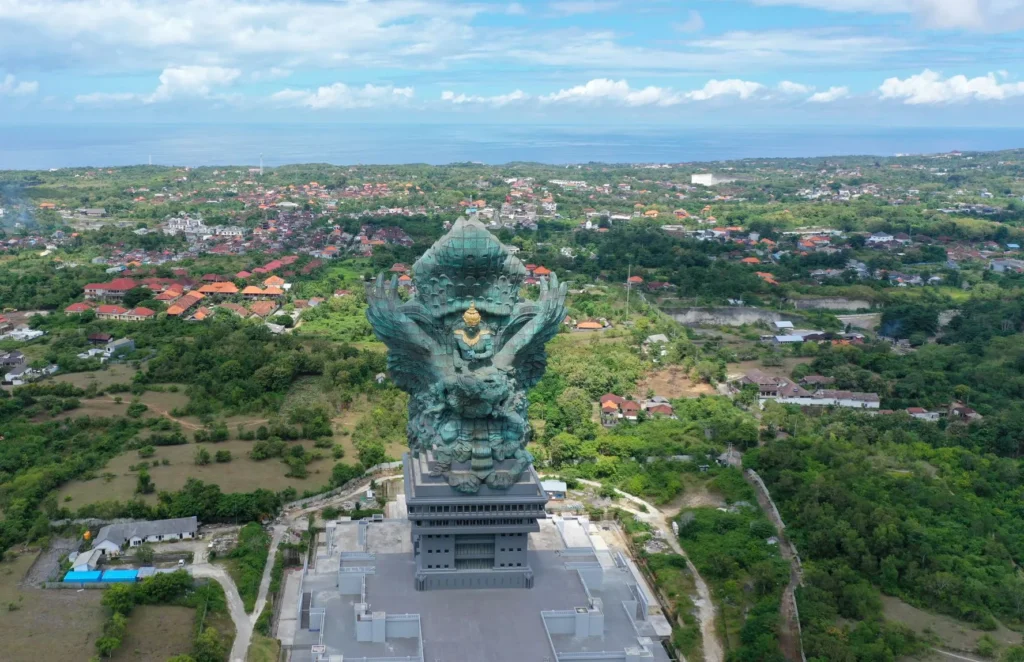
[0,552,104,662]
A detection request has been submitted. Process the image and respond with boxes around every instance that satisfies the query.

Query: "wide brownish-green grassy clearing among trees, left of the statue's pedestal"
[57,441,335,508]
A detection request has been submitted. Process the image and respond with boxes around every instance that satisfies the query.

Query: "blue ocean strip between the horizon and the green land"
[0,124,1024,170]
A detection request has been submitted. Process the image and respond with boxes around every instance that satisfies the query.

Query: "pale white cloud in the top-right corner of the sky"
[752,0,1024,32]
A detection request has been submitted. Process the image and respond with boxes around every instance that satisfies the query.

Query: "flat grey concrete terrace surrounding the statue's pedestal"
[289,520,669,662]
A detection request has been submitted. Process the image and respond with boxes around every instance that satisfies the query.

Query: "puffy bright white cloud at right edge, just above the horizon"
[879,69,1024,105]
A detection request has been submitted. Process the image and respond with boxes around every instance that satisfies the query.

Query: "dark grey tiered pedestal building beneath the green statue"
[401,452,548,590]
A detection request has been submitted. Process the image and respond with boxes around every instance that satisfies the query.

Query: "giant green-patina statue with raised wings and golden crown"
[367,219,565,493]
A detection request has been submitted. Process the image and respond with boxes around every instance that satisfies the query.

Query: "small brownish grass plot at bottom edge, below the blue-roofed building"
[111,605,196,662]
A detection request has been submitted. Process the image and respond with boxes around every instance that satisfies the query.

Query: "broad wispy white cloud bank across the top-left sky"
[0,0,485,70]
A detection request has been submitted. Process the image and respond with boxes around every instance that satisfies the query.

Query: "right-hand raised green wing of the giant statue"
[501,274,567,388]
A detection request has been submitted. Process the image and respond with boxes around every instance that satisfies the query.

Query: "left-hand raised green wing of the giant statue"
[367,275,439,392]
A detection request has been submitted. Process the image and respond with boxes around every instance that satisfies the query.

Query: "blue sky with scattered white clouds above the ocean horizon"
[0,0,1024,126]
